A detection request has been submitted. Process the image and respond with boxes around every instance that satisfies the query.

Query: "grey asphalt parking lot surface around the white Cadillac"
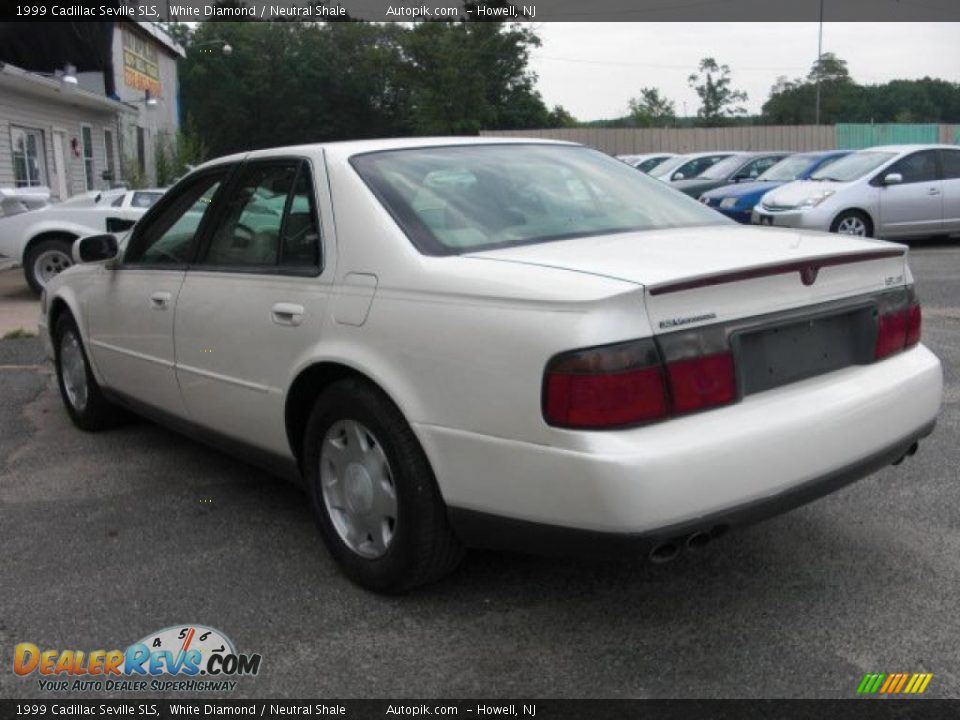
[0,241,960,698]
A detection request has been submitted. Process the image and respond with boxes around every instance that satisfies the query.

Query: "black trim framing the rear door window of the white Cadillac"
[186,155,326,277]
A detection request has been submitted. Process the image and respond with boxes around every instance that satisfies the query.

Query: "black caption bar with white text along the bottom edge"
[0,696,960,720]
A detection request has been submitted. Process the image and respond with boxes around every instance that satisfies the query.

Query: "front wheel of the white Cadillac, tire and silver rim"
[53,314,125,432]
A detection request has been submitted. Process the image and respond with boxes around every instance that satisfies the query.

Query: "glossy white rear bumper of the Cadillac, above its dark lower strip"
[414,345,943,537]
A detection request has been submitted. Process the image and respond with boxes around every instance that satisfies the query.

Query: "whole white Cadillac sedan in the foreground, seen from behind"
[42,138,942,592]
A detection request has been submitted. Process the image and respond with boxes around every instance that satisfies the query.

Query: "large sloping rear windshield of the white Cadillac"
[350,144,729,255]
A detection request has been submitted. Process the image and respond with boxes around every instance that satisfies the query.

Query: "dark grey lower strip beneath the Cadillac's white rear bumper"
[449,423,935,557]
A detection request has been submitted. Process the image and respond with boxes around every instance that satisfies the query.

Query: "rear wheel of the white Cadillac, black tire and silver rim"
[303,379,463,594]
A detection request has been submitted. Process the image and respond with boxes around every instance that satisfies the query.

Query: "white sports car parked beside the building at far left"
[0,189,164,293]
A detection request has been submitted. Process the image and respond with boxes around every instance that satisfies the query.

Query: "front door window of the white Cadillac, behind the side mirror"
[123,170,227,266]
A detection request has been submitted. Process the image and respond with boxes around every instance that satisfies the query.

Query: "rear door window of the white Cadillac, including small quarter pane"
[201,160,320,270]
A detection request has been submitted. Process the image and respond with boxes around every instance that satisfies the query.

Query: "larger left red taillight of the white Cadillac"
[543,340,737,429]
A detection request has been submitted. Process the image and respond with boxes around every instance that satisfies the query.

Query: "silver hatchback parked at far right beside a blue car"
[751,145,960,238]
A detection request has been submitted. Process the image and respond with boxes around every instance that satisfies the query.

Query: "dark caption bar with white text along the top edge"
[0,0,960,22]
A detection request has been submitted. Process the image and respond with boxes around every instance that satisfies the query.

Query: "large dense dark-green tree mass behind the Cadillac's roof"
[180,16,556,156]
